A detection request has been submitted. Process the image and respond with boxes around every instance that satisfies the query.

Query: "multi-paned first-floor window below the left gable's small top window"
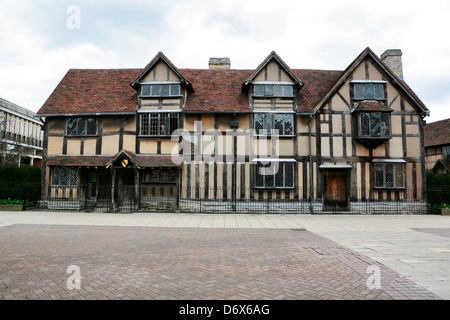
[139,112,178,136]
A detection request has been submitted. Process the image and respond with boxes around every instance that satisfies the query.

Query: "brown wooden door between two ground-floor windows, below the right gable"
[323,169,349,211]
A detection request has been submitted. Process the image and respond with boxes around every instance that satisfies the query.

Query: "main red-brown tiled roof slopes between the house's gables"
[38,69,342,116]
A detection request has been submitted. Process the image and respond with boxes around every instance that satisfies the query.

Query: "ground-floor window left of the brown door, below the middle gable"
[254,160,295,189]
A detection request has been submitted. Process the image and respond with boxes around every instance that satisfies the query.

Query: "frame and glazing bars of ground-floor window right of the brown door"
[373,160,406,190]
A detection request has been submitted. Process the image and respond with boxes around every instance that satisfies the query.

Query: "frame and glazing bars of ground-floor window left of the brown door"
[252,159,296,190]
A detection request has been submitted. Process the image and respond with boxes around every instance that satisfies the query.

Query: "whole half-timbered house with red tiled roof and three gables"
[38,48,429,212]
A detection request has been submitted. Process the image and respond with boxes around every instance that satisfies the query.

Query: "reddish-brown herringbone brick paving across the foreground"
[0,225,439,300]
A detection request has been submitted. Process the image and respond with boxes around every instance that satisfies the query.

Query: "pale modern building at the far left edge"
[0,98,44,166]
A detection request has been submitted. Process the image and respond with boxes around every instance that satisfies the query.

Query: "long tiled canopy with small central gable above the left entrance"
[46,150,183,169]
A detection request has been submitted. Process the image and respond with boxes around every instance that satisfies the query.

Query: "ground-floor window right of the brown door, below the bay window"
[373,162,405,189]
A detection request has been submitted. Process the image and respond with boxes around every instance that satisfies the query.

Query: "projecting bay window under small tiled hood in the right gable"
[358,112,391,138]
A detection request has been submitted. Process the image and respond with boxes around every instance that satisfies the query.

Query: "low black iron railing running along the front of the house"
[0,185,442,214]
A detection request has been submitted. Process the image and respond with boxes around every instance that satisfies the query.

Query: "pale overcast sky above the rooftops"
[0,0,450,122]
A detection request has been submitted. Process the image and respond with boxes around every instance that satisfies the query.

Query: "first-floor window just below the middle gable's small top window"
[254,113,294,137]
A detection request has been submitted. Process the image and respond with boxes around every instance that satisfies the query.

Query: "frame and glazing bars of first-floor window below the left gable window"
[139,112,180,137]
